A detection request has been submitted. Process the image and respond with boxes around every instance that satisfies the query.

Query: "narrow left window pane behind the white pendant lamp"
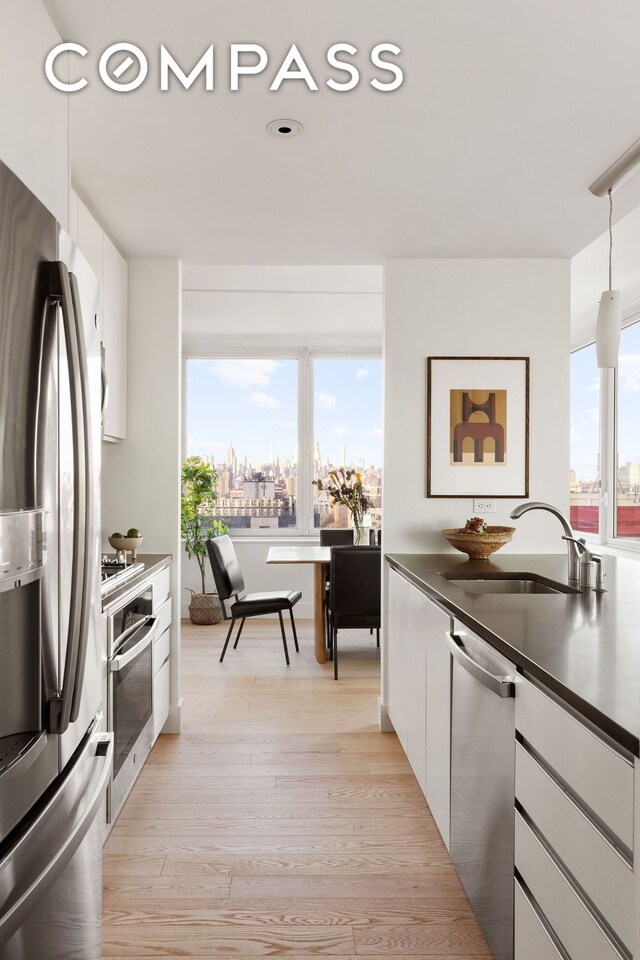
[569,344,600,533]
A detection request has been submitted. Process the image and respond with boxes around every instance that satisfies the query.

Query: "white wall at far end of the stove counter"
[102,260,182,733]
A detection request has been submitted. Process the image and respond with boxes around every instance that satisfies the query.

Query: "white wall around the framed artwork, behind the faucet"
[382,260,570,723]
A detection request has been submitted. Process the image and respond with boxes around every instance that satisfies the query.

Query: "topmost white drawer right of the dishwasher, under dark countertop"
[516,677,633,850]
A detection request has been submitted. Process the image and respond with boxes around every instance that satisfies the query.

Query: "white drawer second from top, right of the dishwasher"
[516,744,634,947]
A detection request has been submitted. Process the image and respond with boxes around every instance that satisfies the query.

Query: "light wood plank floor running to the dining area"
[104,620,491,960]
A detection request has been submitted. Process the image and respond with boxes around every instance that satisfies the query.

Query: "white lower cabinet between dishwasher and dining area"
[387,570,451,847]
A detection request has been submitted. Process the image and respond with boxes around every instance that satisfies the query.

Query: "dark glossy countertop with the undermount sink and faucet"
[387,553,640,757]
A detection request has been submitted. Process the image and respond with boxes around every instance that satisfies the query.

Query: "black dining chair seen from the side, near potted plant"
[206,534,302,666]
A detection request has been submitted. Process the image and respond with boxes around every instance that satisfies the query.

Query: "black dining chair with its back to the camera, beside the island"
[328,547,382,680]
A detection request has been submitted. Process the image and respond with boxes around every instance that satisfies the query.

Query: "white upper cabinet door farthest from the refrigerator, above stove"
[102,236,128,440]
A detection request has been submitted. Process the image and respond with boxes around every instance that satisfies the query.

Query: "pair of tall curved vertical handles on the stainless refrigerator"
[49,260,90,734]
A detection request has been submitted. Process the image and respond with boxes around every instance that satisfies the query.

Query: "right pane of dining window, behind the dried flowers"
[313,357,382,528]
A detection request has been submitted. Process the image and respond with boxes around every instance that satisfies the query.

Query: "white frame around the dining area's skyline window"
[181,343,382,540]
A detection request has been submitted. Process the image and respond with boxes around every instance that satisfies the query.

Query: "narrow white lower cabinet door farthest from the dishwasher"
[386,570,412,753]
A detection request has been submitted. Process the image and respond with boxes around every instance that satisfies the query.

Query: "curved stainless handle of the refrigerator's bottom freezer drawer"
[0,733,113,946]
